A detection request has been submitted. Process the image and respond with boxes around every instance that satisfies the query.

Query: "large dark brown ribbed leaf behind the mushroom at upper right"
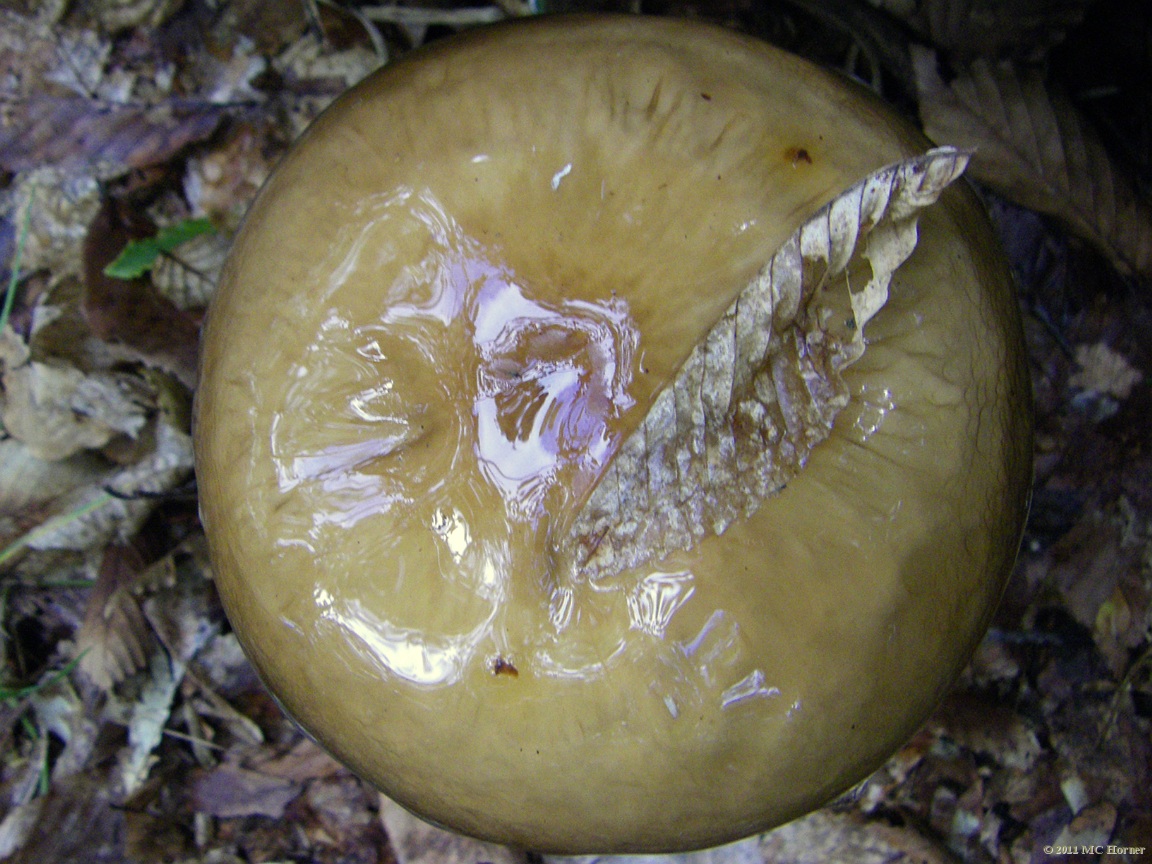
[912,45,1152,278]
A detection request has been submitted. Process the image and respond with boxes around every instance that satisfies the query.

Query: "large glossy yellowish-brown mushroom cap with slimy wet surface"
[196,16,1031,852]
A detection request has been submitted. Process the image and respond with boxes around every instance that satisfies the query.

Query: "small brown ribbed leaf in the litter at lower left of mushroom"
[76,544,154,690]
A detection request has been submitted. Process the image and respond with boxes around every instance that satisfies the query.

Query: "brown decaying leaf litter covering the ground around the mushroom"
[0,0,1152,864]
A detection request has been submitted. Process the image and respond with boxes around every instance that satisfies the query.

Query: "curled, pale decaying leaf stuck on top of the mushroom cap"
[564,147,968,579]
